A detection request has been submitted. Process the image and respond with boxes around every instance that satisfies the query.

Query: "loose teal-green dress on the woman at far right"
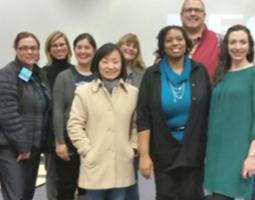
[204,66,255,200]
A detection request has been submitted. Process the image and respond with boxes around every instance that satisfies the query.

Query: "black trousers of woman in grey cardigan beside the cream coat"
[56,154,85,200]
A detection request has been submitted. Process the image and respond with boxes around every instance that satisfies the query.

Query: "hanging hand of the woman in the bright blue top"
[139,154,153,179]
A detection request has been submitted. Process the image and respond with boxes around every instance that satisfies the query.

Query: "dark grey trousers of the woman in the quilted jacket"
[0,147,40,200]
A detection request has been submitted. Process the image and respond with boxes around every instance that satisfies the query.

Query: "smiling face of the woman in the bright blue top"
[164,28,186,60]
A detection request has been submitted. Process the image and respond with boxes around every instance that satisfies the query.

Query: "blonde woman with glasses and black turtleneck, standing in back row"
[43,31,73,200]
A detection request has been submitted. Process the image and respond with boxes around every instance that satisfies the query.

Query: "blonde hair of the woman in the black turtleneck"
[45,31,72,65]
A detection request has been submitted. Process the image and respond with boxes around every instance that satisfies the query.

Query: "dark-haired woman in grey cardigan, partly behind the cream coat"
[53,33,96,200]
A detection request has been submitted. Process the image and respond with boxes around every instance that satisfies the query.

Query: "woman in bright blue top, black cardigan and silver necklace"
[137,26,210,200]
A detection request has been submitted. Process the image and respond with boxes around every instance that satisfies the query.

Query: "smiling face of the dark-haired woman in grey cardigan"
[74,38,96,65]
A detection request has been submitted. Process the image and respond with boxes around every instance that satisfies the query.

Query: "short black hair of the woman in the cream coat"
[91,43,127,80]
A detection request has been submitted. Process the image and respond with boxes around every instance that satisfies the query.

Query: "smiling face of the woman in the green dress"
[228,30,250,63]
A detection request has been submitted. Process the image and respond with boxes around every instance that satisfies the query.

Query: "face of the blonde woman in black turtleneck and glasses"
[50,37,68,60]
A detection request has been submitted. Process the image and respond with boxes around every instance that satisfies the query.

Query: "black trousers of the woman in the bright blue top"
[154,167,203,200]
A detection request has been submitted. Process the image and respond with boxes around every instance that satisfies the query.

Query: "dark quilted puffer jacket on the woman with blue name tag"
[0,60,50,153]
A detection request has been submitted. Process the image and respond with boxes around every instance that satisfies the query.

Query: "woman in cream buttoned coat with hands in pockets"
[67,43,137,200]
